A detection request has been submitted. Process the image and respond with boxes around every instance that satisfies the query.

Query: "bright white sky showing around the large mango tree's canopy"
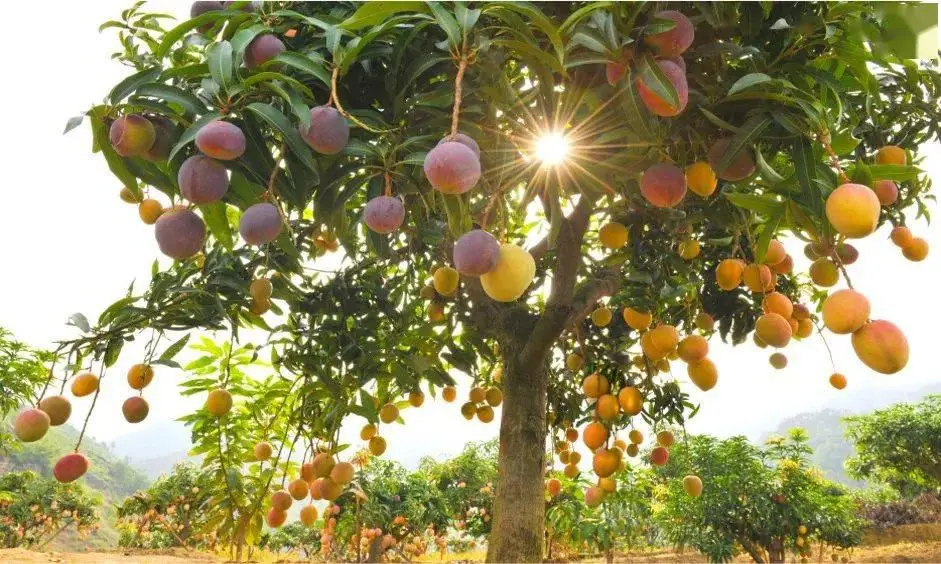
[0,0,941,460]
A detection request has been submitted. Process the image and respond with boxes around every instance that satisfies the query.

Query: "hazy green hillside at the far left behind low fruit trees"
[0,425,151,550]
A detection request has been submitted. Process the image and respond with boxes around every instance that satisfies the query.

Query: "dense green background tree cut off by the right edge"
[844,395,941,496]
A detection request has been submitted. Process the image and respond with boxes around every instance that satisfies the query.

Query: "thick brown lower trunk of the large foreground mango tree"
[487,350,546,562]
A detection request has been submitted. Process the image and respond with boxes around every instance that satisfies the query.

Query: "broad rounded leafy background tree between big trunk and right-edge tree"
[655,430,863,562]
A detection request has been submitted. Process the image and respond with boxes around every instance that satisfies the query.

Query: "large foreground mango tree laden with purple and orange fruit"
[14,2,941,561]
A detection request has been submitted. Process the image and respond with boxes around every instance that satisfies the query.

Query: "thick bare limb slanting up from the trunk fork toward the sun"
[520,196,594,366]
